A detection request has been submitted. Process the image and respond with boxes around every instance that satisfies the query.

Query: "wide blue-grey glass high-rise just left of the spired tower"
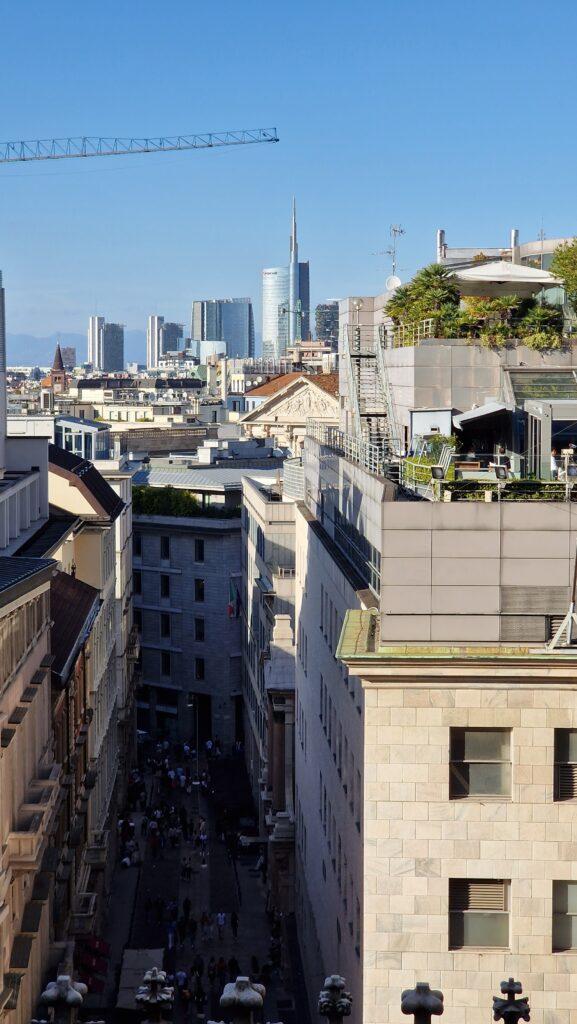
[191,298,254,359]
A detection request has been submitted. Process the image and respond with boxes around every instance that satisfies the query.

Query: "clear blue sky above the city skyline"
[0,0,577,344]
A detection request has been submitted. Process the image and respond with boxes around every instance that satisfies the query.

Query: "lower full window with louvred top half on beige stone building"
[449,879,509,949]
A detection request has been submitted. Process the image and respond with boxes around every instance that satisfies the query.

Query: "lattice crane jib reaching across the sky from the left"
[0,128,279,164]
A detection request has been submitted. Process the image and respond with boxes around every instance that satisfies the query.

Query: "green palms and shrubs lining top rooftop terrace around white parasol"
[386,251,577,351]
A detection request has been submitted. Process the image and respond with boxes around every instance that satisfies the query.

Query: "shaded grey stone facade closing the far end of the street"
[133,515,241,750]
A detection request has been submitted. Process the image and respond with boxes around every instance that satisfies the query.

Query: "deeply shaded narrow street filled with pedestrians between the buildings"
[86,757,301,1024]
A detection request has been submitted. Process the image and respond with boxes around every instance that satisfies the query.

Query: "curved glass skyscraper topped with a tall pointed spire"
[262,200,311,359]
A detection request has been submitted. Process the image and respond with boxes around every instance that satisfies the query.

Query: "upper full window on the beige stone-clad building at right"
[449,729,511,800]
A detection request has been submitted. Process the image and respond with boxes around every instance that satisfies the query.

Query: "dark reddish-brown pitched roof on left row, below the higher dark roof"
[50,572,99,676]
